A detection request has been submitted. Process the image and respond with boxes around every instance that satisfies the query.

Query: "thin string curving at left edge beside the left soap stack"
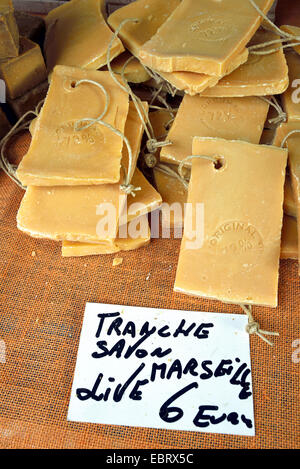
[0,99,45,190]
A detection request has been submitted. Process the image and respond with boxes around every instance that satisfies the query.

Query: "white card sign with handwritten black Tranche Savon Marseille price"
[68,303,255,436]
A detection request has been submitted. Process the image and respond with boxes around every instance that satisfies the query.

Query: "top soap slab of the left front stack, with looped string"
[17,65,129,186]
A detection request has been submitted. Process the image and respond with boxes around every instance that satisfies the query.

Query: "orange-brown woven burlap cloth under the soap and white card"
[0,134,300,449]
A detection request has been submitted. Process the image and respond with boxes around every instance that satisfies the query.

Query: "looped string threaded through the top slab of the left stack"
[74,79,141,197]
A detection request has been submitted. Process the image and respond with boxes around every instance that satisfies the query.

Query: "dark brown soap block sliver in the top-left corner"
[0,0,19,60]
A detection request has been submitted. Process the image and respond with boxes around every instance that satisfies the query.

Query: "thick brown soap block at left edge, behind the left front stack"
[0,37,47,99]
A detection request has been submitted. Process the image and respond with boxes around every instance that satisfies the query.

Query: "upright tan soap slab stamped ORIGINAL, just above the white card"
[175,137,287,307]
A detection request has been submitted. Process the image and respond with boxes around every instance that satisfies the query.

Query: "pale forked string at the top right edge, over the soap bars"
[248,0,300,55]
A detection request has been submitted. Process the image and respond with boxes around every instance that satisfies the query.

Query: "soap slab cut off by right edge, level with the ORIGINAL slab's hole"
[274,122,300,275]
